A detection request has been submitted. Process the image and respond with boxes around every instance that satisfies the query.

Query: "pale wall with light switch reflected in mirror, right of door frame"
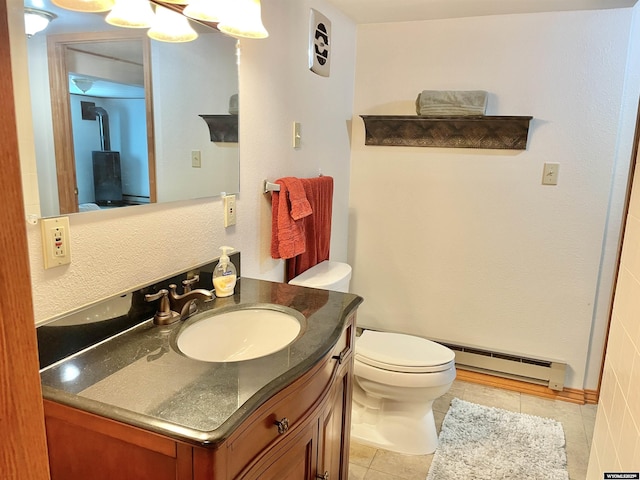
[151,32,240,202]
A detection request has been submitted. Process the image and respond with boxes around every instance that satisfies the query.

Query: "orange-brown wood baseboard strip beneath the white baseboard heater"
[457,367,598,405]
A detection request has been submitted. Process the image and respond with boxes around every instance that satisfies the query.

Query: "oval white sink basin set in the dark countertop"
[176,307,302,362]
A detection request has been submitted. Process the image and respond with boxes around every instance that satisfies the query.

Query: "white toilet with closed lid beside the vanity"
[289,261,456,455]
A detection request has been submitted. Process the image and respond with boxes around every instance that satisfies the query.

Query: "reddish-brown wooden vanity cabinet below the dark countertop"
[45,314,355,480]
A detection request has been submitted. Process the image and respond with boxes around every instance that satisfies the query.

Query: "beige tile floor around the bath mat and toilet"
[349,380,597,480]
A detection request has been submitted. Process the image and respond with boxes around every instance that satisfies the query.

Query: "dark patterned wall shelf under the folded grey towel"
[360,115,533,150]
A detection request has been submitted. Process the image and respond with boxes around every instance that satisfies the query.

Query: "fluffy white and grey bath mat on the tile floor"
[427,398,569,480]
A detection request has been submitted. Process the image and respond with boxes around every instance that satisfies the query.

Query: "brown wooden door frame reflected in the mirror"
[47,30,157,215]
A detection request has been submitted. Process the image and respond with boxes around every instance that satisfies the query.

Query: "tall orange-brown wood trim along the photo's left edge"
[0,0,50,480]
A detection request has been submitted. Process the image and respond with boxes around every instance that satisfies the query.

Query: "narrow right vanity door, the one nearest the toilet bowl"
[318,357,352,480]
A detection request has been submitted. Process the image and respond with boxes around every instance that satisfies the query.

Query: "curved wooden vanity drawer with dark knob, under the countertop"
[227,325,352,478]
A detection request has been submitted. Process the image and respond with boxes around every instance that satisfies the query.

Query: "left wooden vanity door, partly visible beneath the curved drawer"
[241,419,318,480]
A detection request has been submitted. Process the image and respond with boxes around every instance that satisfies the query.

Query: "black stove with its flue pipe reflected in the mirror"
[89,106,123,206]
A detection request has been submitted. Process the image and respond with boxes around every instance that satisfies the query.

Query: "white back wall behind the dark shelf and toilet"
[349,9,638,389]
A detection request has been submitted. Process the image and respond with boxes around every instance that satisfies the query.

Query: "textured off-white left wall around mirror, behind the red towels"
[11,0,355,322]
